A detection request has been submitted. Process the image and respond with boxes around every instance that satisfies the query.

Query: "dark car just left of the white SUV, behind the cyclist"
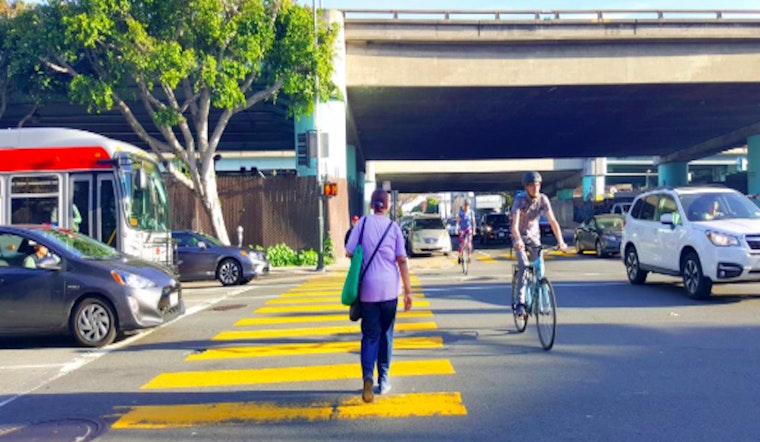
[574,213,625,258]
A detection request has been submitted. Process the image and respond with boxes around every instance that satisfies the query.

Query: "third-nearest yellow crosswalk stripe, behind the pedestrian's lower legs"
[185,336,443,361]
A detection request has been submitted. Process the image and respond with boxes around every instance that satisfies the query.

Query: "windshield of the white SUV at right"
[680,192,760,221]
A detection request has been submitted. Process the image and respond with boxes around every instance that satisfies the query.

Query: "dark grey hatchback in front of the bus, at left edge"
[0,225,185,347]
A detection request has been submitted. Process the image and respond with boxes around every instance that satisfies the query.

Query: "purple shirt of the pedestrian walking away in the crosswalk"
[346,214,406,302]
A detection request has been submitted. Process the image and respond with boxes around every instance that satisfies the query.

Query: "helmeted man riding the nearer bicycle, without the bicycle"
[510,172,567,315]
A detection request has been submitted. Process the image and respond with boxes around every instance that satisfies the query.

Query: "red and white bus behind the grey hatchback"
[0,128,173,265]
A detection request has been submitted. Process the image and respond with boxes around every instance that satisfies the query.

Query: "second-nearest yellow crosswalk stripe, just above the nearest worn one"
[140,359,455,390]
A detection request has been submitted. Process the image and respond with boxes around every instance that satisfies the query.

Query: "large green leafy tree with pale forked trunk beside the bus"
[13,0,337,244]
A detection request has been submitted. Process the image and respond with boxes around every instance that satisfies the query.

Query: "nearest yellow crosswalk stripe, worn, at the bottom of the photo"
[111,394,467,430]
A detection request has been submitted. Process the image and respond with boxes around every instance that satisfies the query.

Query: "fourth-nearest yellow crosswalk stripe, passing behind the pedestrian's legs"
[211,322,438,341]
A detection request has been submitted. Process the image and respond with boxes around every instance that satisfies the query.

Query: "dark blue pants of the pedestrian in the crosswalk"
[361,299,398,385]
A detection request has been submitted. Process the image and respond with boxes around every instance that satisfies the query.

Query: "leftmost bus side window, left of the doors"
[10,175,60,224]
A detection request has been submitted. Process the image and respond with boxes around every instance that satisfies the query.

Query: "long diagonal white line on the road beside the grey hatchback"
[0,287,250,408]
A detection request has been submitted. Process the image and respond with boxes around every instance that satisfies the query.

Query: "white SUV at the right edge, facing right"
[620,187,760,299]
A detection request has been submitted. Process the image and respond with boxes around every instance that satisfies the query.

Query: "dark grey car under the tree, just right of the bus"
[172,230,270,286]
